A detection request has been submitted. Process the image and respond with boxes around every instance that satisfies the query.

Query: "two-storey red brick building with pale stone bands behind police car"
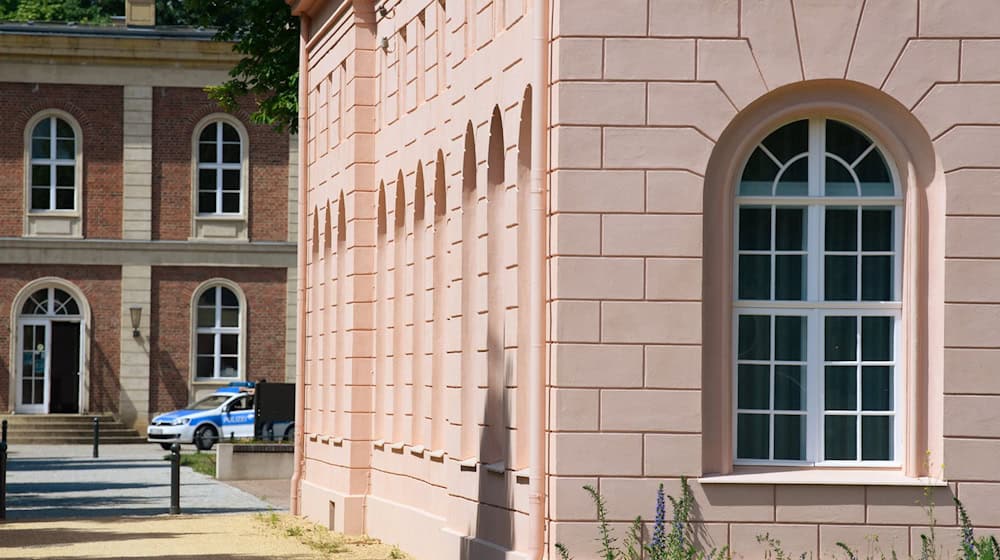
[0,0,297,429]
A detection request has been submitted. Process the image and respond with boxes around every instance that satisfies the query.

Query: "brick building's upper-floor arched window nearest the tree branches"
[197,120,244,215]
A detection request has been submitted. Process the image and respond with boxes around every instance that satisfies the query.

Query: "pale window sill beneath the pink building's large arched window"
[698,469,948,487]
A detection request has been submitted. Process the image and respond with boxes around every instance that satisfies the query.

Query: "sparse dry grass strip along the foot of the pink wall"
[257,511,410,560]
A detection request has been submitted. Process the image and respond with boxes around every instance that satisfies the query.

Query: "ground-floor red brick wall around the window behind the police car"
[149,267,286,412]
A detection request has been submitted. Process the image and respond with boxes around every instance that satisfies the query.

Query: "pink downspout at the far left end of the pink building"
[290,9,309,515]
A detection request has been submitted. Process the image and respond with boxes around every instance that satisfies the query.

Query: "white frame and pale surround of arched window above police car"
[190,278,247,384]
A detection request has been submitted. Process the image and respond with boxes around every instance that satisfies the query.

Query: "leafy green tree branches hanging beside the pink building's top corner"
[183,0,299,132]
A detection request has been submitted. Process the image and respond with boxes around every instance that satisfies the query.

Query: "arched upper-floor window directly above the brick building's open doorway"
[29,114,79,212]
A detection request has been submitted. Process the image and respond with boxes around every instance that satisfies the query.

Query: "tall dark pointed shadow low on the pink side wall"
[461,336,515,560]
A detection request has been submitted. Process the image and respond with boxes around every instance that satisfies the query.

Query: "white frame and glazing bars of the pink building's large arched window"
[730,116,906,468]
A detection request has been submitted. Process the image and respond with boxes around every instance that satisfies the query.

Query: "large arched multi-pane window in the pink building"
[733,118,905,466]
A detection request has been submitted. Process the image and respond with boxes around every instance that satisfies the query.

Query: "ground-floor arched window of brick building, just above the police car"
[195,285,244,379]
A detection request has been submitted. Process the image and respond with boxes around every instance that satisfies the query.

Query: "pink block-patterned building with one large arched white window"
[289,0,1000,560]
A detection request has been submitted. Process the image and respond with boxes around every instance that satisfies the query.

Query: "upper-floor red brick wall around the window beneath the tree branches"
[153,88,289,241]
